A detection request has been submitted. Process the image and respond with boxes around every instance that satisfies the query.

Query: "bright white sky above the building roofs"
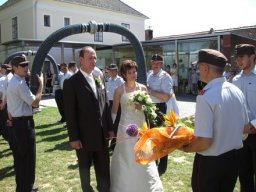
[0,0,256,37]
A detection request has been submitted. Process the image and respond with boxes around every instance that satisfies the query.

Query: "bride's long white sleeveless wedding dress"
[110,87,164,192]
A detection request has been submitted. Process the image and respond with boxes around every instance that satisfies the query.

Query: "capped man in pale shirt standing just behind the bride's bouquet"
[147,54,173,175]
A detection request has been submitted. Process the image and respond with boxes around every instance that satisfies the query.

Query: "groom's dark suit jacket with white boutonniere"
[63,71,113,151]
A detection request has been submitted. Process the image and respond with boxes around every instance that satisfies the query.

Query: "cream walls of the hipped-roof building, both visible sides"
[0,0,145,66]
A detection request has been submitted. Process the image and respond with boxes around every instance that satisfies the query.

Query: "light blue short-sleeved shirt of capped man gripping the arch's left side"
[7,74,35,117]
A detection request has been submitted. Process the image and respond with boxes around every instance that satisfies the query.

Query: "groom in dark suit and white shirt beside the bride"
[63,46,114,192]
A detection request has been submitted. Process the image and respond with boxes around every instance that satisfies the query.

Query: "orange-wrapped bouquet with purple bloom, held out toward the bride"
[126,111,194,164]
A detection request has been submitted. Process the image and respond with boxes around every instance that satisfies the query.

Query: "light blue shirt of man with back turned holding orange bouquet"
[194,77,248,156]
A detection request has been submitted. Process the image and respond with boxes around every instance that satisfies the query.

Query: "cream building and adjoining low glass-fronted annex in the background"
[0,0,256,93]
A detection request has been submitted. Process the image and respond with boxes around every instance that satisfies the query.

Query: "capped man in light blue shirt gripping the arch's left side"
[7,54,43,192]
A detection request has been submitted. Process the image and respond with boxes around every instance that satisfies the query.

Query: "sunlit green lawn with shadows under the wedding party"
[0,107,238,192]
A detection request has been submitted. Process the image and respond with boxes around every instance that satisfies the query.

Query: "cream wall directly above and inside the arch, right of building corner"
[36,0,145,45]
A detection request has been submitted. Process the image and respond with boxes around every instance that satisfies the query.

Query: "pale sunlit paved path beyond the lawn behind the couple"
[40,95,196,118]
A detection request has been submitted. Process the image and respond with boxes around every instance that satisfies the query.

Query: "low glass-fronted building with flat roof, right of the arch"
[109,26,256,93]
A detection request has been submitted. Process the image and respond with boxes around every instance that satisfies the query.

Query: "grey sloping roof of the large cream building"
[0,0,149,19]
